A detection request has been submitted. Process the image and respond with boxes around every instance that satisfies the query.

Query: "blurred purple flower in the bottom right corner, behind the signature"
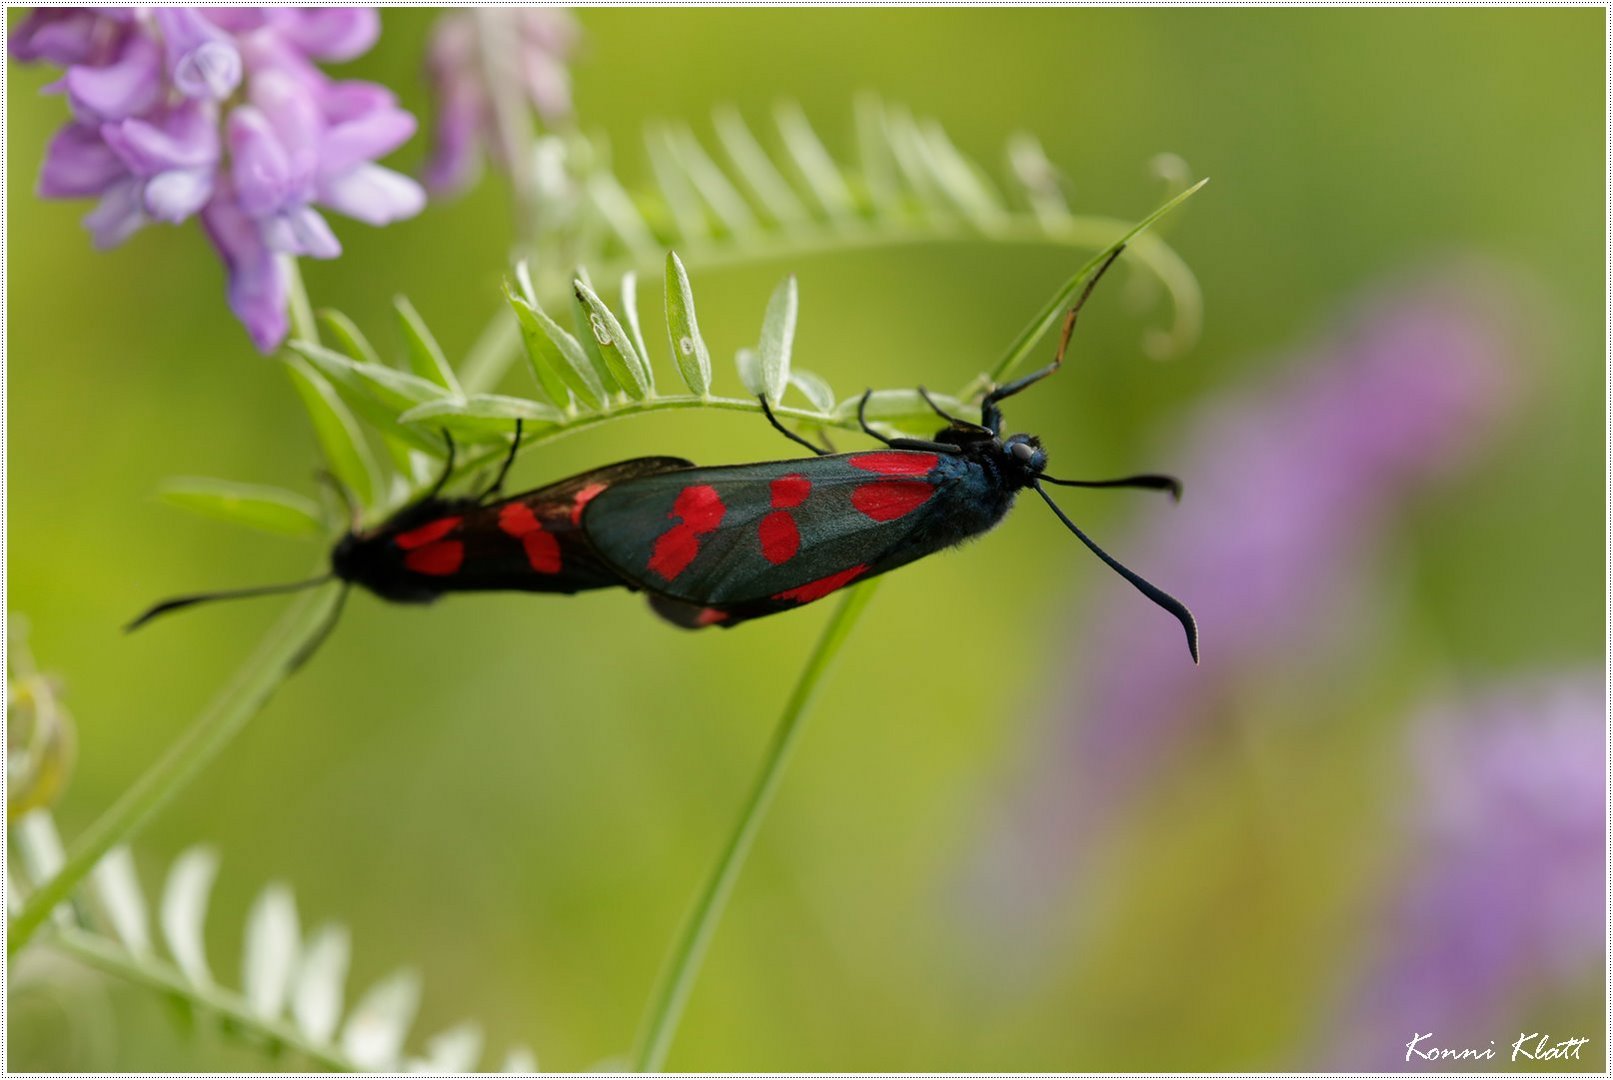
[1326,671,1607,1069]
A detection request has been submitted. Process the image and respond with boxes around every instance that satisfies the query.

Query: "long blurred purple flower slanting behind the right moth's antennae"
[965,265,1516,924]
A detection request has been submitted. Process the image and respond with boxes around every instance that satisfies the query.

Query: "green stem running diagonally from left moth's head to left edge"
[6,588,337,956]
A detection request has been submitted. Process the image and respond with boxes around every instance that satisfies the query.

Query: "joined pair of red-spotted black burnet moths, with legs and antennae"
[131,250,1198,663]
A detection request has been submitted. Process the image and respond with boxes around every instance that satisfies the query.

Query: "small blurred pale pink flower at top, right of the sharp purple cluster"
[424,8,577,192]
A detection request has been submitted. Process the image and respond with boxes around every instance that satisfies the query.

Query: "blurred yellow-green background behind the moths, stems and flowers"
[6,10,1605,1070]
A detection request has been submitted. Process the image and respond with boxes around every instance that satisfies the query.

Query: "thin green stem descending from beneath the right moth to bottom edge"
[632,579,879,1072]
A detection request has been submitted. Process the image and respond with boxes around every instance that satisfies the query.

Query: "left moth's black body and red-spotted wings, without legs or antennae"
[374,458,690,598]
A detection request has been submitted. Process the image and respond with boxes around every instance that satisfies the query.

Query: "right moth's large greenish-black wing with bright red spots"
[582,450,1011,627]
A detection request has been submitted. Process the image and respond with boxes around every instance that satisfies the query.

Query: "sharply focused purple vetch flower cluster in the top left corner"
[10,8,426,351]
